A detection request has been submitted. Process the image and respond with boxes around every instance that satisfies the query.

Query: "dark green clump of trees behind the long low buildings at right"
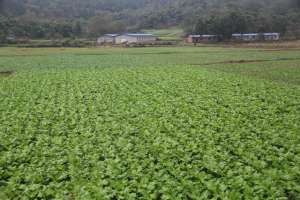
[187,11,300,39]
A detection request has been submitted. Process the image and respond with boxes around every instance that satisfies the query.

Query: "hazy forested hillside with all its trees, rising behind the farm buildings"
[0,0,300,39]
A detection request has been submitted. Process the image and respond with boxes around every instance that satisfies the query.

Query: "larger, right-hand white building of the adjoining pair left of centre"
[115,33,156,44]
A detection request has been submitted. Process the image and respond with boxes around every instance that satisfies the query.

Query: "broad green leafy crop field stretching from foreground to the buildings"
[0,47,300,200]
